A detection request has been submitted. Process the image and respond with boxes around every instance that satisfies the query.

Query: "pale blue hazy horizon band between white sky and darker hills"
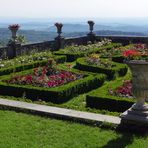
[0,17,148,25]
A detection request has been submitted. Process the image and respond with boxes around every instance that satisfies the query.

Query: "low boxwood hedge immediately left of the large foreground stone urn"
[86,71,134,112]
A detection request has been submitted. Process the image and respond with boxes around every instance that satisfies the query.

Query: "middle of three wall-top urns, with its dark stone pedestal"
[55,23,65,50]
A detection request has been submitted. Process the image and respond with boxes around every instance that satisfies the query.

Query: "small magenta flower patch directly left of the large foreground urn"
[109,80,133,98]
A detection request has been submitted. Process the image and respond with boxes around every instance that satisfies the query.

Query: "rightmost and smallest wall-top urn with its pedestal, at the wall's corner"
[87,21,96,43]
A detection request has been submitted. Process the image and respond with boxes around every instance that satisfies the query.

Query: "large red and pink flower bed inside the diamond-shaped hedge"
[6,60,83,87]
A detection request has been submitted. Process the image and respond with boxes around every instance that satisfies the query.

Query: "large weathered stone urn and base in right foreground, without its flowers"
[120,60,148,126]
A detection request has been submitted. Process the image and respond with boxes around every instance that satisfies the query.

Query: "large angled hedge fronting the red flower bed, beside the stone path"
[0,70,106,104]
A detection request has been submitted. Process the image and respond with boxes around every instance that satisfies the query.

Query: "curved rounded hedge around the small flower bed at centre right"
[76,58,128,79]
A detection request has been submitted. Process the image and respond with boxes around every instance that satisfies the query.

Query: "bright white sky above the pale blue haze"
[0,0,148,18]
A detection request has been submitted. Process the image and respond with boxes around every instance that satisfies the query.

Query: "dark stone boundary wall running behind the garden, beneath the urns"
[0,35,148,59]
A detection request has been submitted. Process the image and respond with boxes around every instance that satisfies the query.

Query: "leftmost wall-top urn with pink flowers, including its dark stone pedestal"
[7,24,21,59]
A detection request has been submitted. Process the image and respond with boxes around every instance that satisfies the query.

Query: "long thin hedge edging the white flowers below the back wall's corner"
[53,43,121,62]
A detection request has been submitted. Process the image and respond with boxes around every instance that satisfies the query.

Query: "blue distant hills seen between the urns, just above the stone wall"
[0,24,146,45]
